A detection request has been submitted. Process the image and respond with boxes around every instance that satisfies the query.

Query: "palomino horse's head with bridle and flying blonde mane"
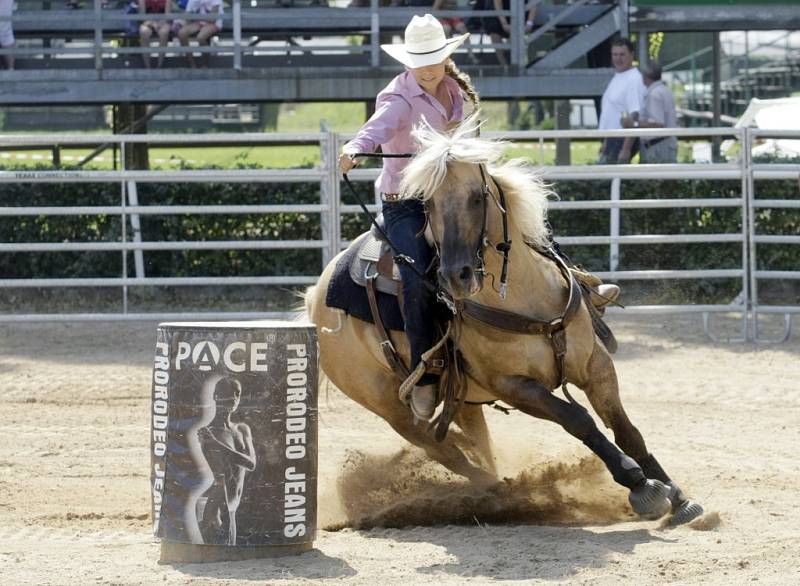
[400,116,547,299]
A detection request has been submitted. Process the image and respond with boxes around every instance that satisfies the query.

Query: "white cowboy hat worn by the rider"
[381,14,469,69]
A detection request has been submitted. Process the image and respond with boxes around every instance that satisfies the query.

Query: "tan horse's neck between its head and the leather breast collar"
[474,207,569,319]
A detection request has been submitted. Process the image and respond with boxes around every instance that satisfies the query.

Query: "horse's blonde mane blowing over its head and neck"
[400,112,553,246]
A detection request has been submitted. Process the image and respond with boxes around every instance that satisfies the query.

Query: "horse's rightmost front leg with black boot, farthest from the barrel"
[584,344,703,525]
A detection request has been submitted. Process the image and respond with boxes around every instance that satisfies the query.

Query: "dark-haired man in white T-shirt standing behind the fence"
[598,38,645,165]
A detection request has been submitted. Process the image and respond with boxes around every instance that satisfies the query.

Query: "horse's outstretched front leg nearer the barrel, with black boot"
[495,376,671,519]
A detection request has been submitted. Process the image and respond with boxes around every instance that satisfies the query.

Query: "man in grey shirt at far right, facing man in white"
[622,61,678,163]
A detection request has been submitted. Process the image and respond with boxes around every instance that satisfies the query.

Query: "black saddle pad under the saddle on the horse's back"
[325,234,404,331]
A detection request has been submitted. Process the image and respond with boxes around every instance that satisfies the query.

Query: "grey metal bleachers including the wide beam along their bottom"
[0,0,625,104]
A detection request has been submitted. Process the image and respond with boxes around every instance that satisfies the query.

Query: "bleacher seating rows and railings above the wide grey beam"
[6,0,613,70]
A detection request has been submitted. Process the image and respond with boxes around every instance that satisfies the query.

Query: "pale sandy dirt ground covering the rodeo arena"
[0,316,800,585]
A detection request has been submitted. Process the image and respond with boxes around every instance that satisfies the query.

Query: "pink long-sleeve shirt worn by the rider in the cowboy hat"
[343,71,464,193]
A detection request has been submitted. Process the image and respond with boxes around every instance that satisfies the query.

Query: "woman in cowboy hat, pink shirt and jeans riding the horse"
[339,14,478,421]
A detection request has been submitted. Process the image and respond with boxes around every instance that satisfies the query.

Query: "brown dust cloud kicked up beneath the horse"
[323,450,635,531]
